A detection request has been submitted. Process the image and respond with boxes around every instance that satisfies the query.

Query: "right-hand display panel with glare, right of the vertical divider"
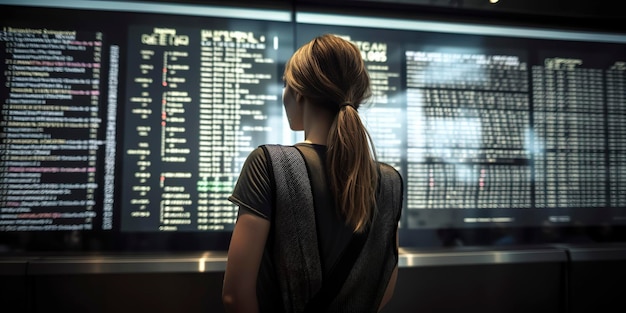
[297,12,626,246]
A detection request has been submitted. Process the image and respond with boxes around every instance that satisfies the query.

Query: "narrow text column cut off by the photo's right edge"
[606,61,626,208]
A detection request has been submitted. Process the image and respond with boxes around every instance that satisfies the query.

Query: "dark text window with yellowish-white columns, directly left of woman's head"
[121,26,282,231]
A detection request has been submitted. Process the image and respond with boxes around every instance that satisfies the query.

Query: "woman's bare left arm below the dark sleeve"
[222,212,270,313]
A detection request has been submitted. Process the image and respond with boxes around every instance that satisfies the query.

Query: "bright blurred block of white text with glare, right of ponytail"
[406,50,531,219]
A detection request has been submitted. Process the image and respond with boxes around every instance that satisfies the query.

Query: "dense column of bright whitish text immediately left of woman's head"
[197,29,279,230]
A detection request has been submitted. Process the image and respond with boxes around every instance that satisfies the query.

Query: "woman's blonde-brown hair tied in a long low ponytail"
[284,34,378,232]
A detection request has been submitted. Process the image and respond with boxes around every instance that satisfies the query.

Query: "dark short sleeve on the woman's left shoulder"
[228,147,272,220]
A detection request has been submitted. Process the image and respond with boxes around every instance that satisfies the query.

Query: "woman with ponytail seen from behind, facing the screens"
[222,34,403,313]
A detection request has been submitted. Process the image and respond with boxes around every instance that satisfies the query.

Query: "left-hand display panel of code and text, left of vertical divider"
[0,1,296,252]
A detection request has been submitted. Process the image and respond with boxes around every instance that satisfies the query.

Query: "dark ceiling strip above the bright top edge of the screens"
[118,0,626,33]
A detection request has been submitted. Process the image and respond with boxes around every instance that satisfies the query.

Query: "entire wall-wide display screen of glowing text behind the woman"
[0,1,626,252]
